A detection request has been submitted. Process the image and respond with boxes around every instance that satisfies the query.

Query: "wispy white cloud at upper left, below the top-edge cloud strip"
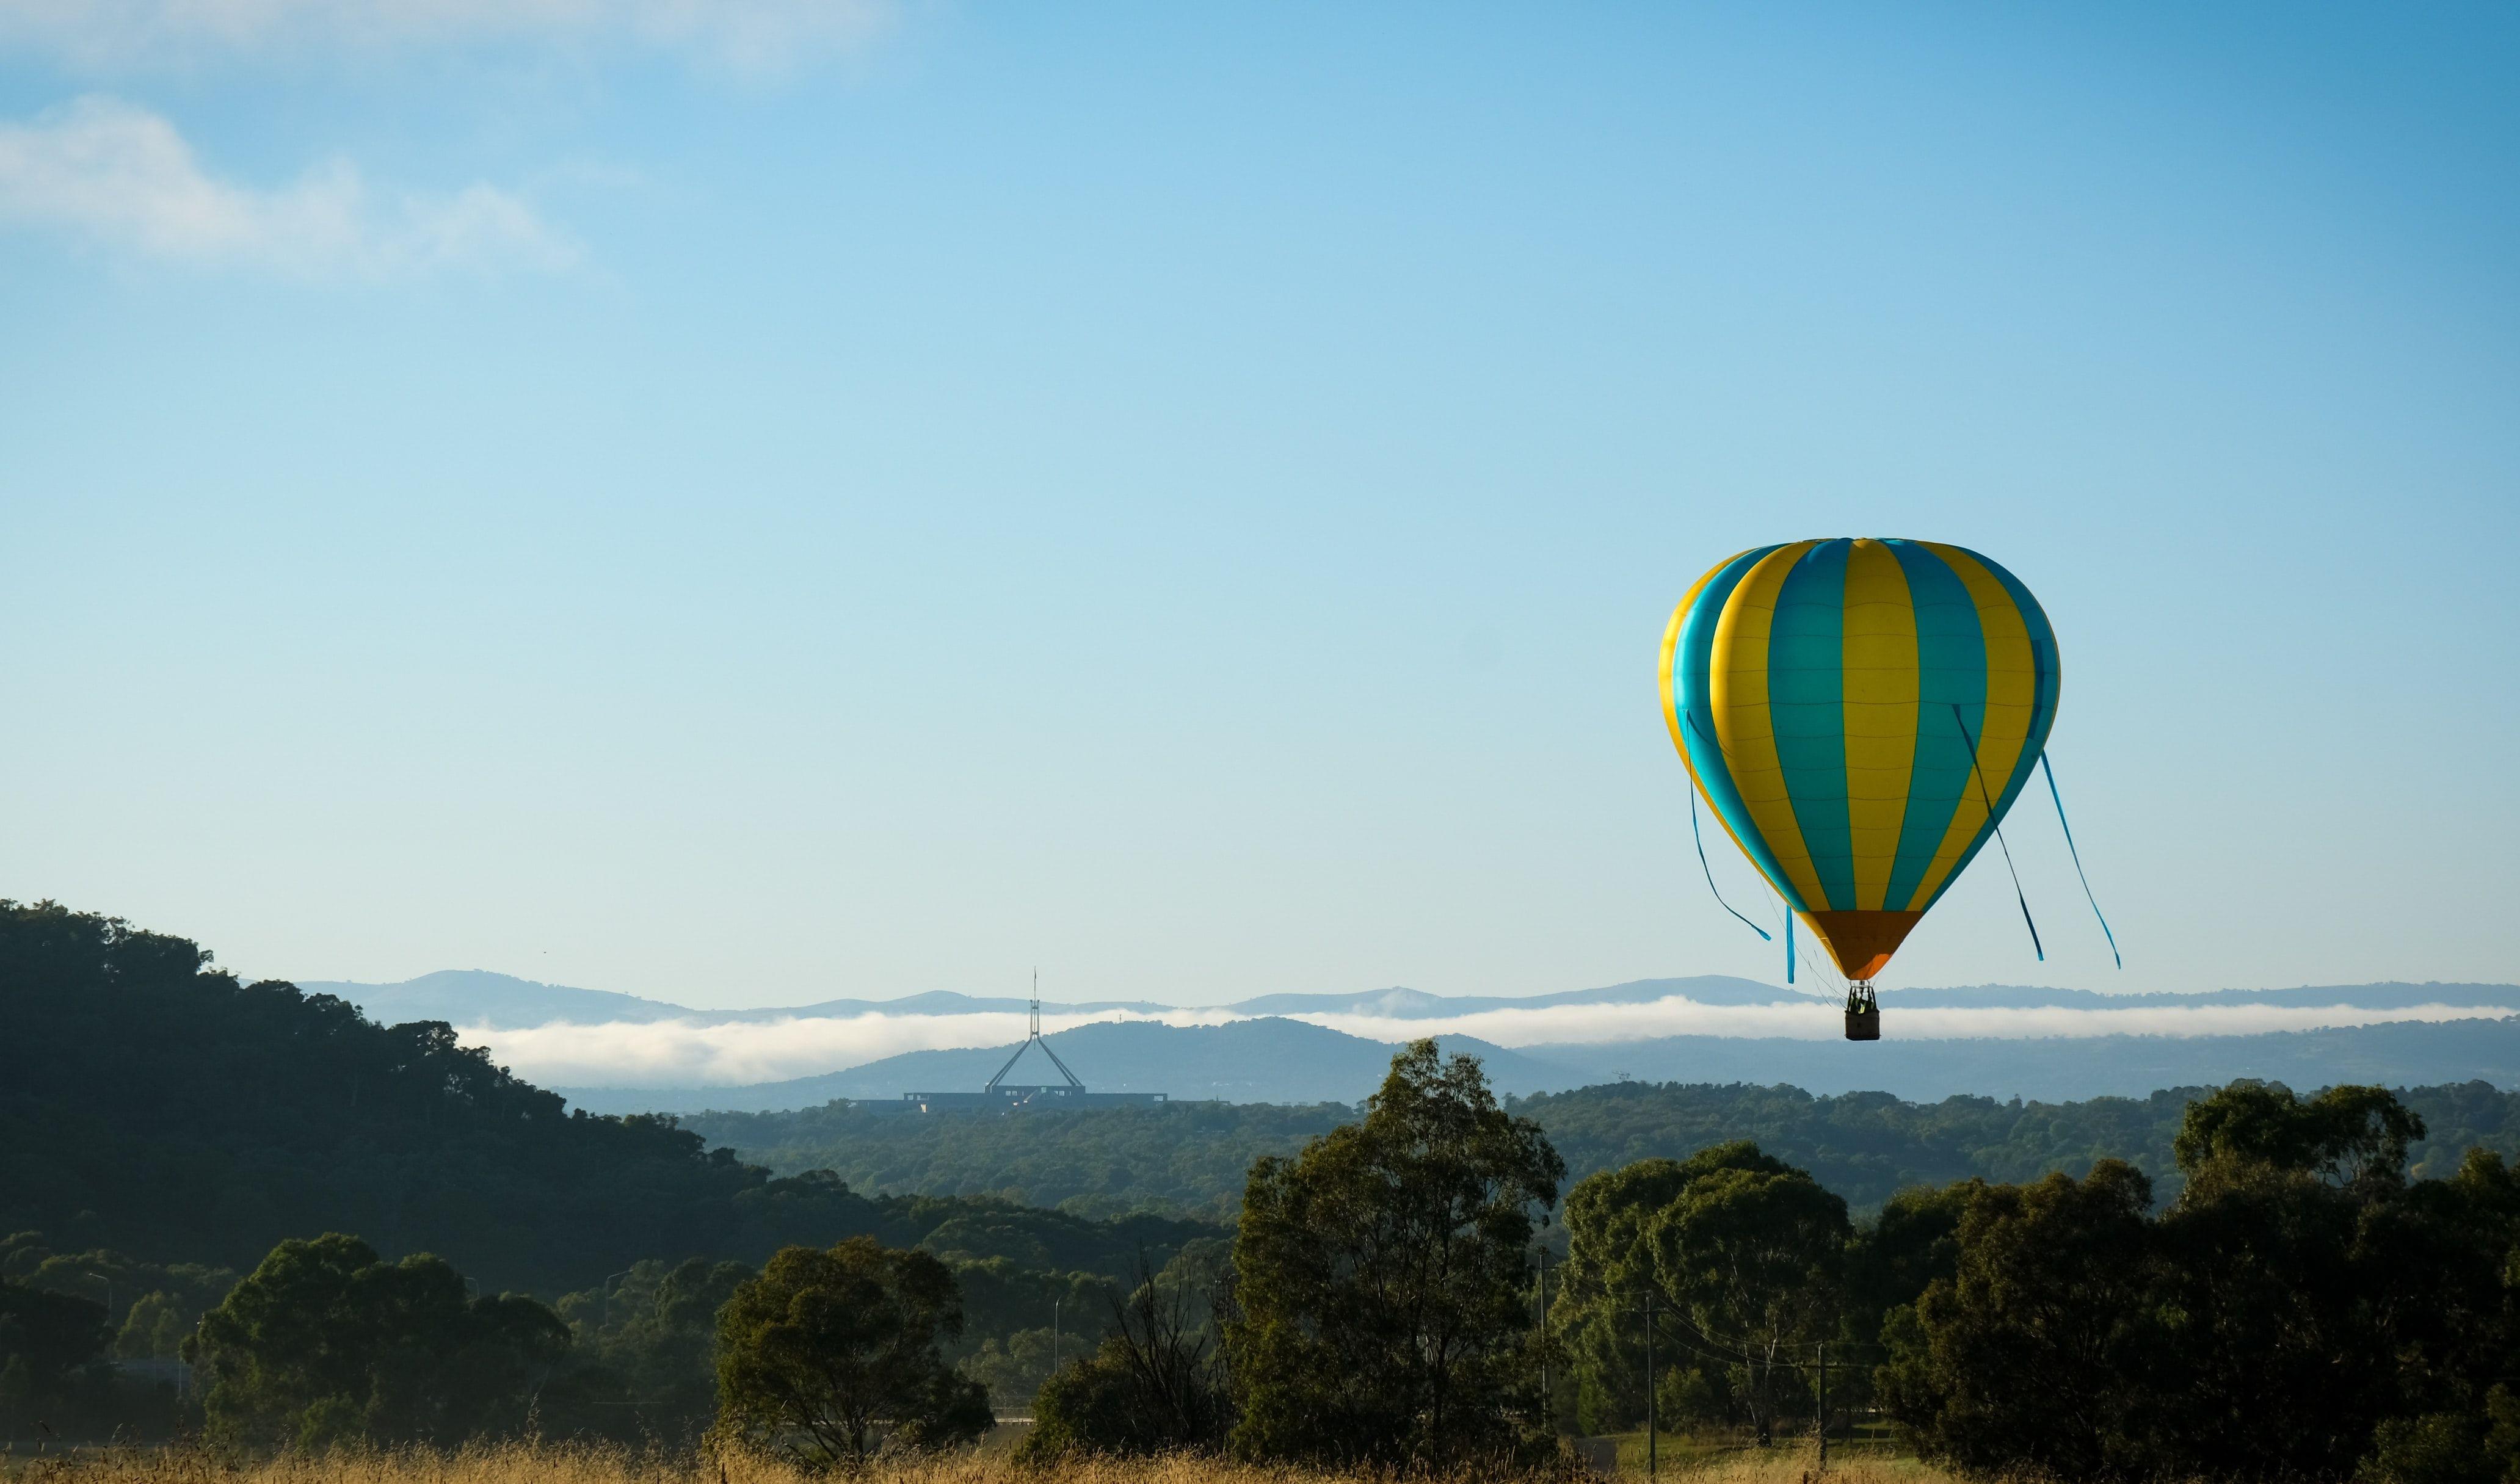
[0,95,577,277]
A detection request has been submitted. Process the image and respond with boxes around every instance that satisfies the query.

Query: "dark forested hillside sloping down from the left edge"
[0,902,1227,1436]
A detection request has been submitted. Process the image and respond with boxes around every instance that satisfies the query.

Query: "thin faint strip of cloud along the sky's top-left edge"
[0,0,892,73]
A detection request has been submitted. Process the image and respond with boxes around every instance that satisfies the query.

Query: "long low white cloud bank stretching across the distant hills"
[463,997,2510,1086]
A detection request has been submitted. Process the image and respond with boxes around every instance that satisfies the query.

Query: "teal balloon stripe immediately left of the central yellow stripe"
[1767,539,1854,912]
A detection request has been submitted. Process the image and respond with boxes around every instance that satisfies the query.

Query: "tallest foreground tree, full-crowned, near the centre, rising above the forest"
[1225,1041,1565,1466]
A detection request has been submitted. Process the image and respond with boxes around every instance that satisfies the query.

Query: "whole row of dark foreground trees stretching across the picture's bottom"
[24,1018,2520,1484]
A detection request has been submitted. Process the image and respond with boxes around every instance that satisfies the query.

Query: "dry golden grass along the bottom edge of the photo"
[0,1444,1948,1484]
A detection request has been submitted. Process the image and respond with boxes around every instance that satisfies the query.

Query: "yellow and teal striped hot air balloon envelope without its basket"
[1661,539,2059,980]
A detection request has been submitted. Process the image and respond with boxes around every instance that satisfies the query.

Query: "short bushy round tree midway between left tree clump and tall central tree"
[718,1237,995,1466]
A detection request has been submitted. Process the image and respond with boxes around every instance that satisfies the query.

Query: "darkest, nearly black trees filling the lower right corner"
[1875,1084,2520,1484]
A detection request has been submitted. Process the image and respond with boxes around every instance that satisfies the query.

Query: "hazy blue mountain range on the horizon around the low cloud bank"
[300,970,2520,1113]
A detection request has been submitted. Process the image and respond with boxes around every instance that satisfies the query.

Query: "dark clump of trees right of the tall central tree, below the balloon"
[1557,1084,2520,1484]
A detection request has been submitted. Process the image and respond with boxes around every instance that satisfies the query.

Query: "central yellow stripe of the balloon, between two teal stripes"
[1842,539,1918,912]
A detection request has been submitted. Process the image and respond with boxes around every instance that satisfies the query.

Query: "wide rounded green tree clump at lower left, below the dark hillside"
[184,1232,570,1449]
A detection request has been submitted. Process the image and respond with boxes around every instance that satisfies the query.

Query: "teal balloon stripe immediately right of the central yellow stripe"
[1883,541,1986,912]
